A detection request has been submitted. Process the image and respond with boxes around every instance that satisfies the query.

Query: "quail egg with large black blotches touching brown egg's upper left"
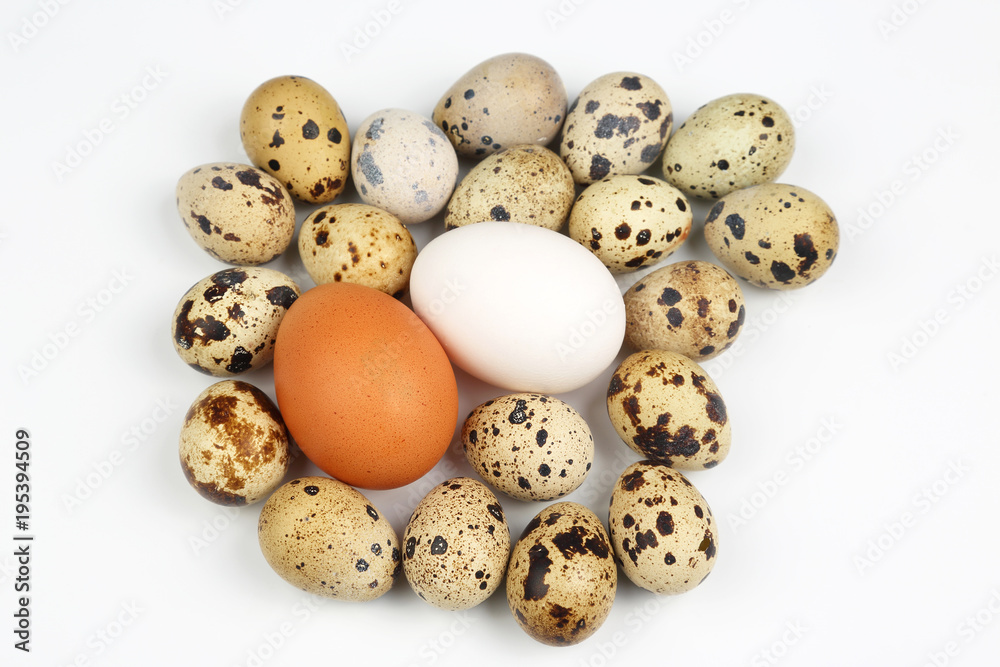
[172,267,300,377]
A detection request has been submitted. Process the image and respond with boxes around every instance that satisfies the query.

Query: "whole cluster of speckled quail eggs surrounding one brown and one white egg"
[172,53,839,646]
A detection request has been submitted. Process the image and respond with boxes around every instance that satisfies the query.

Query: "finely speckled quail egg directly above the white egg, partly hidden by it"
[444,145,576,231]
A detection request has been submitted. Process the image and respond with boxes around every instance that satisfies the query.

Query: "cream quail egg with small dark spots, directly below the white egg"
[462,394,594,500]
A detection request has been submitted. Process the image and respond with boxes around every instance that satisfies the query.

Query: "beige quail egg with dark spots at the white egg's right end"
[625,261,746,361]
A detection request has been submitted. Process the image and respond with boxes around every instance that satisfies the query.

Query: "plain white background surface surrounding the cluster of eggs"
[0,0,1000,667]
